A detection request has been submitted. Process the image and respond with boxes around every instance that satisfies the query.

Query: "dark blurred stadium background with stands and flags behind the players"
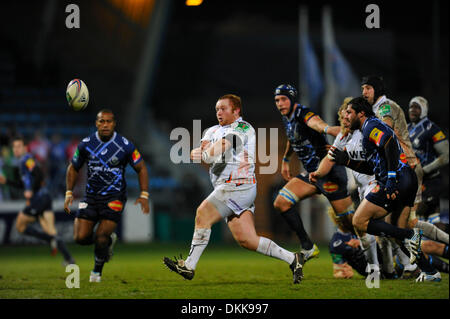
[0,0,449,247]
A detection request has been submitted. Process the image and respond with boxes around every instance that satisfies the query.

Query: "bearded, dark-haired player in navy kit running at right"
[330,97,440,281]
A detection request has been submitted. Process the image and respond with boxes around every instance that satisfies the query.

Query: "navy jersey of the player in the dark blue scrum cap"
[283,104,328,173]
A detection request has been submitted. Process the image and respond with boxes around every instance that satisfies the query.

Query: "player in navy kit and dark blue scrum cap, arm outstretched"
[274,84,354,261]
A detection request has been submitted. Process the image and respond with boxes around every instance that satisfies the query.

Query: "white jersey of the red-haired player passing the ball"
[201,117,256,188]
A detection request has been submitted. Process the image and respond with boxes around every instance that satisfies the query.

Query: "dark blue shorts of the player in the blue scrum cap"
[296,165,349,201]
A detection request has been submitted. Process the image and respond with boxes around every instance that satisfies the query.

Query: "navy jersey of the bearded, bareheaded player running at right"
[361,117,408,184]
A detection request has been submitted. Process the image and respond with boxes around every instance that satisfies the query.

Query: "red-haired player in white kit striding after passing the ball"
[164,94,304,284]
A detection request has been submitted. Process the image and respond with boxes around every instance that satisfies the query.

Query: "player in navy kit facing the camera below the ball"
[64,109,150,282]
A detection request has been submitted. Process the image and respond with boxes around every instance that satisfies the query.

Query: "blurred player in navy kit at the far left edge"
[0,137,75,265]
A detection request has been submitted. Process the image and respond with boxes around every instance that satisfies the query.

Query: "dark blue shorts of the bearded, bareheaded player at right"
[366,166,418,213]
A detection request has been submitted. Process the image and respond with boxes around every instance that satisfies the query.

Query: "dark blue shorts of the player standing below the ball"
[76,196,127,223]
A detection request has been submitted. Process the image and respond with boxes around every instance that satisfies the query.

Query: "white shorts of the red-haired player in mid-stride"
[206,184,256,221]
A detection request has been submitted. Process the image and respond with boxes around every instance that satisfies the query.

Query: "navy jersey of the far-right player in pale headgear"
[408,117,446,175]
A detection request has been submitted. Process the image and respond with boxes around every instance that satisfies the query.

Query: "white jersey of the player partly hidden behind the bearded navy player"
[333,130,375,194]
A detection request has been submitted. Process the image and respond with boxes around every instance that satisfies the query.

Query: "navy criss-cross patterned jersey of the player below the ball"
[72,132,142,196]
